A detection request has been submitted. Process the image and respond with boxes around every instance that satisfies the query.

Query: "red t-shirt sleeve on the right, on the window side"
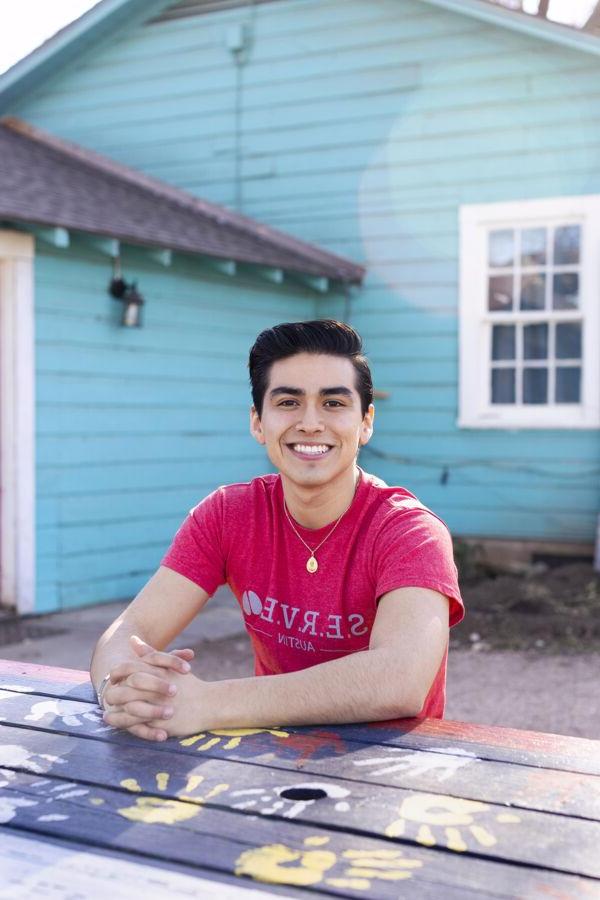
[373,506,464,626]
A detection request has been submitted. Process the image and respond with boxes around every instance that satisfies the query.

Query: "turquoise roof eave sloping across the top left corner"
[0,0,172,109]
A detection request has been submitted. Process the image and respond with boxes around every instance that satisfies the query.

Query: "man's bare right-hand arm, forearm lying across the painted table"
[106,588,448,735]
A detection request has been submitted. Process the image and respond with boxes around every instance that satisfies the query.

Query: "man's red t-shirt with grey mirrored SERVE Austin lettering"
[162,470,464,718]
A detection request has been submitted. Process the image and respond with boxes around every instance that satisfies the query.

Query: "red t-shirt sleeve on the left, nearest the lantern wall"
[161,489,227,596]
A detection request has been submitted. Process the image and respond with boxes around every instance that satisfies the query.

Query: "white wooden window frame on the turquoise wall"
[457,194,600,429]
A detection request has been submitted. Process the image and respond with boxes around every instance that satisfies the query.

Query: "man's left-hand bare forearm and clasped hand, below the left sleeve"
[90,566,208,738]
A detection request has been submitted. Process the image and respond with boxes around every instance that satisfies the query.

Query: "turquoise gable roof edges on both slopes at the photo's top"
[0,0,600,109]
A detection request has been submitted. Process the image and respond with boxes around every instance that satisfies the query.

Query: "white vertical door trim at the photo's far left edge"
[0,229,36,613]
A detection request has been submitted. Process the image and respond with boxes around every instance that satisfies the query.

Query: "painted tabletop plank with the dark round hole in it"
[0,727,600,878]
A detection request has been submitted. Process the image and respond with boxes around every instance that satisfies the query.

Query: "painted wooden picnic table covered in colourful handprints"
[0,660,600,900]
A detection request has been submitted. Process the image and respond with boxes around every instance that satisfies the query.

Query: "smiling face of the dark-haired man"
[250,353,374,487]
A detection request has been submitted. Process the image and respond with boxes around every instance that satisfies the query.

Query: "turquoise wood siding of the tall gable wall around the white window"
[15,0,600,592]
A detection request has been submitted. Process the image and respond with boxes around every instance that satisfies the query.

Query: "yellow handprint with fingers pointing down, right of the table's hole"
[385,794,521,853]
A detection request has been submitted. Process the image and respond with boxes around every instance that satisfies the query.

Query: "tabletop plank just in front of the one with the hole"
[2,773,597,900]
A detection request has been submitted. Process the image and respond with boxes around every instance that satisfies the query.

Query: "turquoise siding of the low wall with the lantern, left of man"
[35,242,316,612]
